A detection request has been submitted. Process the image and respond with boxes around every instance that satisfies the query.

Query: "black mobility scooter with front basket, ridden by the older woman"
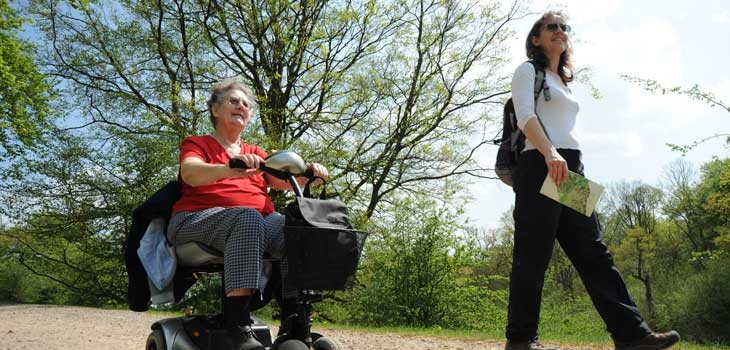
[140,151,366,350]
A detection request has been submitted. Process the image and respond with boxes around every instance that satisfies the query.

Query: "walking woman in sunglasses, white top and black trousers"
[506,11,679,350]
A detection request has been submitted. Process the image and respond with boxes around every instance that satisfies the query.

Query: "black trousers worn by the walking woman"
[506,149,651,342]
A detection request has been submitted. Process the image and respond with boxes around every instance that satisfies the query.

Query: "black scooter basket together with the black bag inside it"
[284,180,365,290]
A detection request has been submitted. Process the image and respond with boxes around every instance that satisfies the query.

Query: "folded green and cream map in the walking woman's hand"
[540,171,603,216]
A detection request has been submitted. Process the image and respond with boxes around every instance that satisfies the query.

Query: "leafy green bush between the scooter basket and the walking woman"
[351,198,469,327]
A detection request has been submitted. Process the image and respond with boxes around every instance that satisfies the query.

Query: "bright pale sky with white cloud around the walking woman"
[467,0,730,232]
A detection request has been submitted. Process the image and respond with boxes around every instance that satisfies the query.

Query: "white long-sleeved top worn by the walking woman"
[512,62,580,151]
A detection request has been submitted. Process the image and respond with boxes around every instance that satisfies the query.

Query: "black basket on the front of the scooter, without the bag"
[284,226,367,290]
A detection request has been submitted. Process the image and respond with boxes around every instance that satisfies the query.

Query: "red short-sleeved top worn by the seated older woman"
[172,135,274,216]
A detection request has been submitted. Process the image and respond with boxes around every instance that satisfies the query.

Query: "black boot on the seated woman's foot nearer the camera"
[223,296,264,350]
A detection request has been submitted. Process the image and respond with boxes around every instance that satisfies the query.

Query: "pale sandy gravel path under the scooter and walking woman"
[0,305,609,350]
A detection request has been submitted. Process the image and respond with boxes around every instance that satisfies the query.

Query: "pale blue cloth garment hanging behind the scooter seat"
[137,218,177,290]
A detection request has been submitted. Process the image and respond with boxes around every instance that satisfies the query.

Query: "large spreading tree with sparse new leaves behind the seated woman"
[0,0,521,301]
